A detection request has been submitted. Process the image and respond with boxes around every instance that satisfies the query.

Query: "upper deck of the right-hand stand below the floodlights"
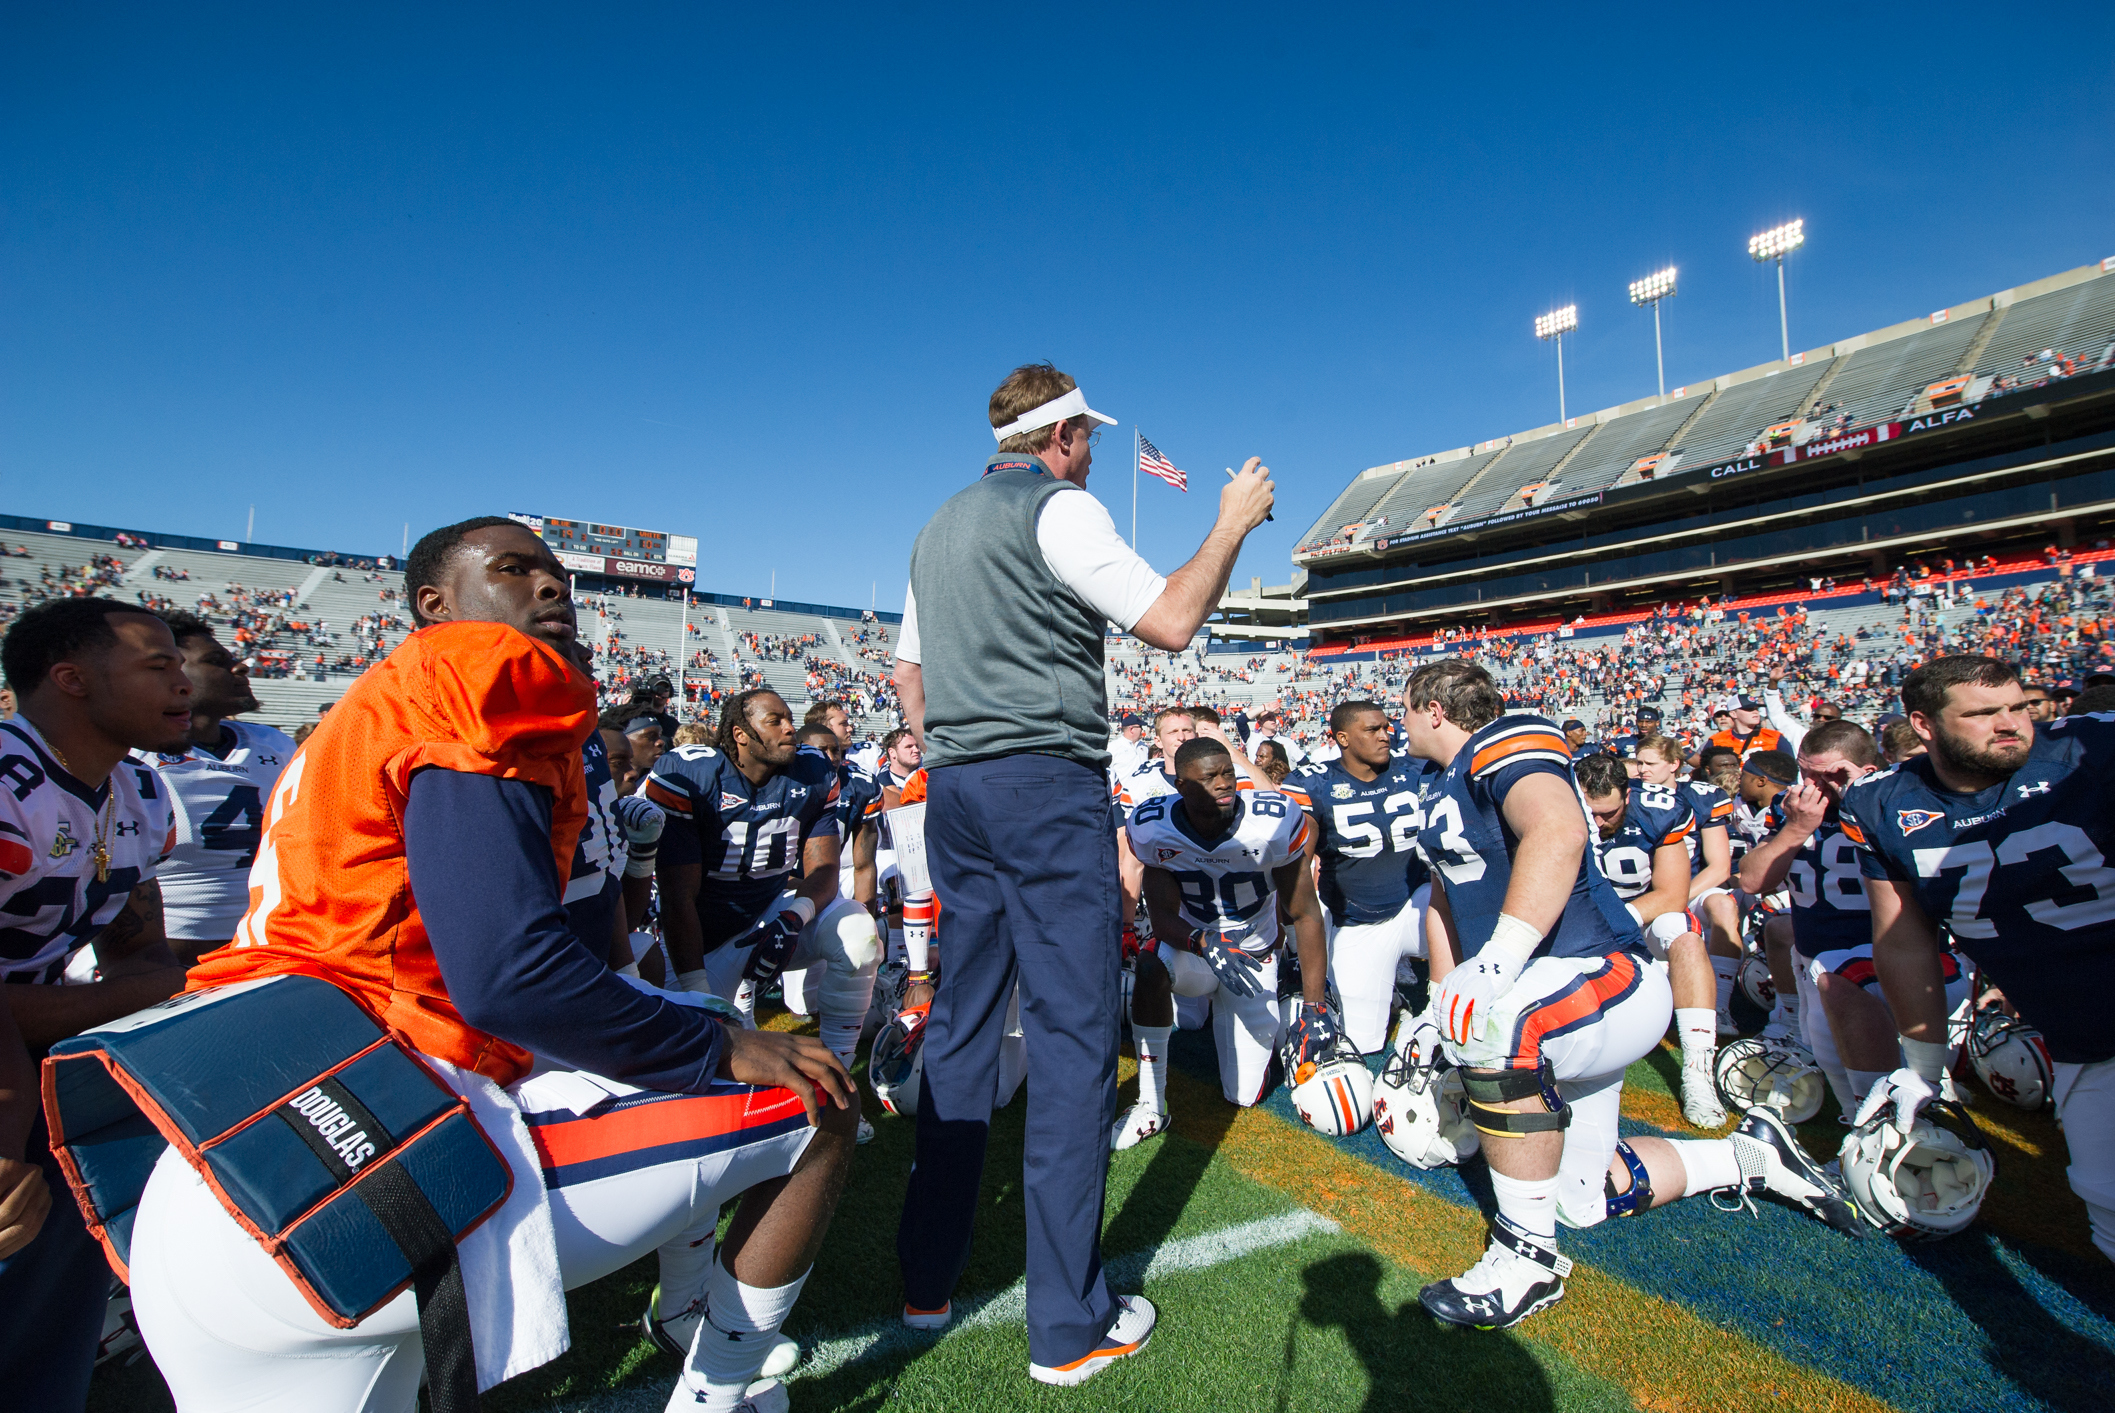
[1292,258,2115,645]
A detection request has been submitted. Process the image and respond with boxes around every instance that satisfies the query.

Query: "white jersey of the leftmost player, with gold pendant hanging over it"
[0,717,176,981]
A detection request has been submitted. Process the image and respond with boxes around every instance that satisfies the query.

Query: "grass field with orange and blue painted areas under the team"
[91,1002,2115,1413]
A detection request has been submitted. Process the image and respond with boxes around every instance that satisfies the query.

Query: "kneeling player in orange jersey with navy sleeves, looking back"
[113,518,859,1413]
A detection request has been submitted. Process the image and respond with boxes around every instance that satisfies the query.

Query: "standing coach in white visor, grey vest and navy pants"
[897,364,1271,1383]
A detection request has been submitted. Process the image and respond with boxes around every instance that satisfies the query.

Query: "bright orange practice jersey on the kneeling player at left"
[188,624,594,1085]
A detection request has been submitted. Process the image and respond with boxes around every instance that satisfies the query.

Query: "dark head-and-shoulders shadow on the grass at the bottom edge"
[1277,1252,1557,1413]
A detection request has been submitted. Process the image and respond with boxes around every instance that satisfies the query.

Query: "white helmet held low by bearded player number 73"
[1836,1100,1997,1242]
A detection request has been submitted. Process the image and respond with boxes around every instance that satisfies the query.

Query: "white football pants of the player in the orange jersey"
[131,1070,814,1413]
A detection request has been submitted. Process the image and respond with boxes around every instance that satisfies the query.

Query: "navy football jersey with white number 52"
[1286,755,1430,926]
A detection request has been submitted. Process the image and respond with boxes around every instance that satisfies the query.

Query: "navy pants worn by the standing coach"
[897,755,1121,1366]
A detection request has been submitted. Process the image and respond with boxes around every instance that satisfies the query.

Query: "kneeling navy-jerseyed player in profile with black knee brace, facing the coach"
[1402,660,1859,1328]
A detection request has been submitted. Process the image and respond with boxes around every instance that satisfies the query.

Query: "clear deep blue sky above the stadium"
[0,2,2115,607]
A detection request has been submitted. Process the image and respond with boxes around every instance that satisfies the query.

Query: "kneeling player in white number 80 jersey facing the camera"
[1110,736,1328,1149]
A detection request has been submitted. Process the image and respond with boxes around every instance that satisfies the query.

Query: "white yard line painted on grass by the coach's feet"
[552,1208,1339,1413]
